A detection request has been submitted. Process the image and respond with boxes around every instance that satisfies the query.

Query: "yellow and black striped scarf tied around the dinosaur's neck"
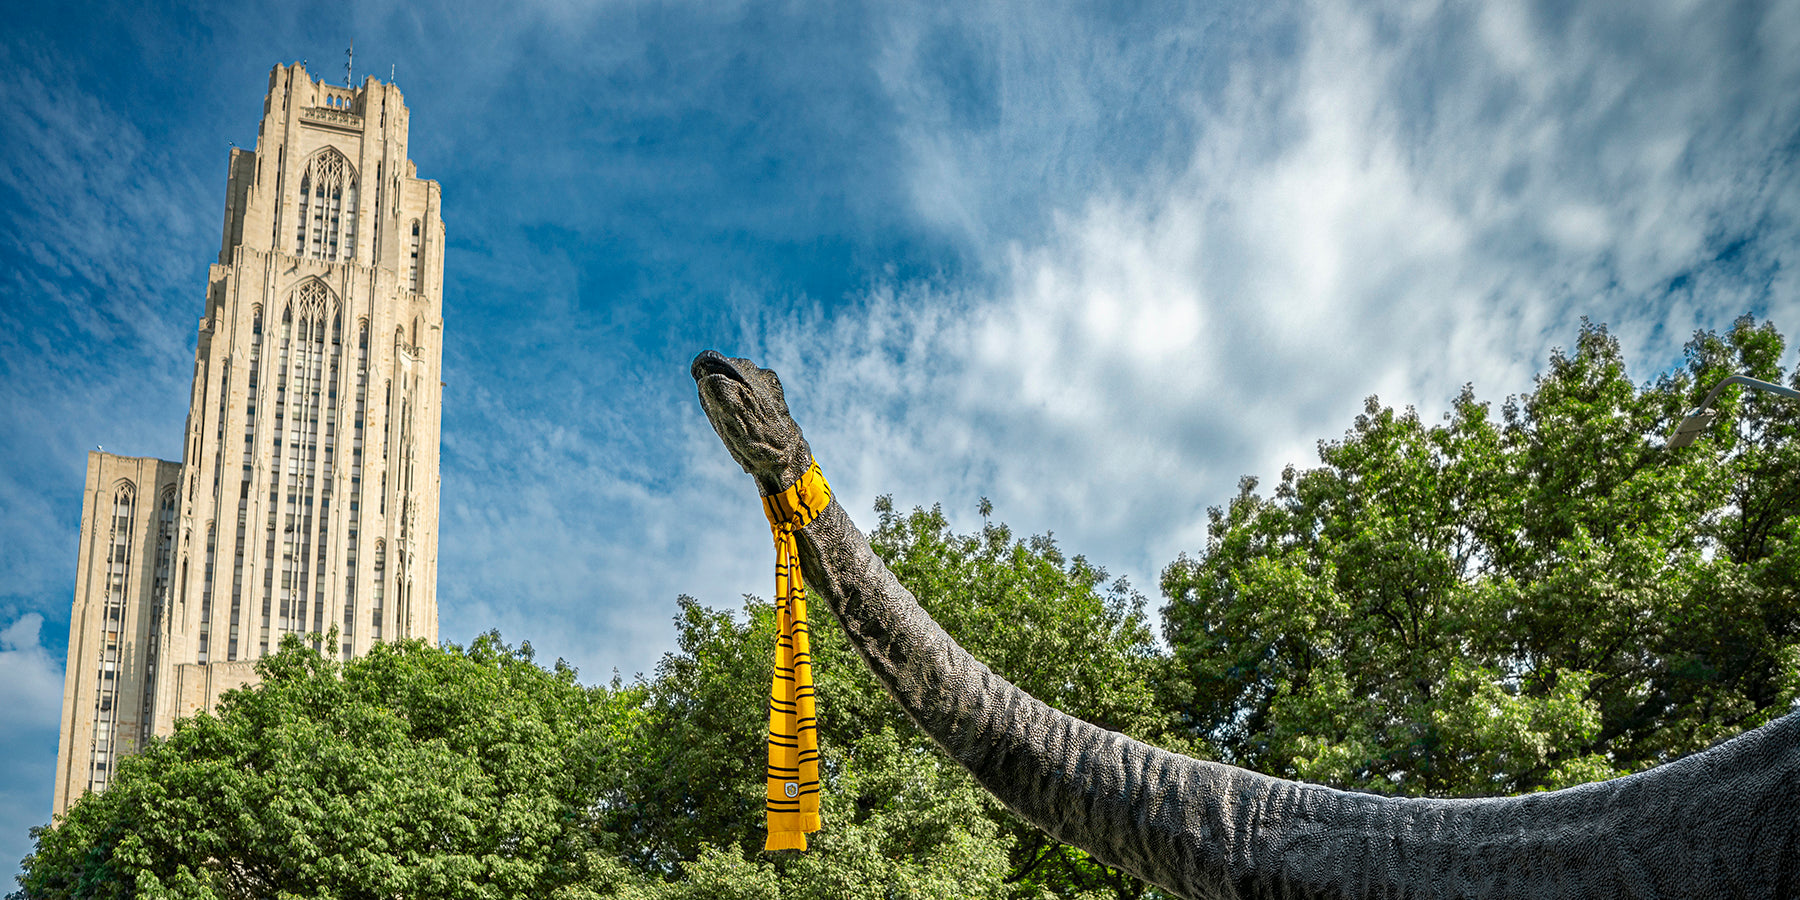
[763,463,832,850]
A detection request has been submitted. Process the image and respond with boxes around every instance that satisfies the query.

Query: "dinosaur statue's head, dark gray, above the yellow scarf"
[691,349,812,495]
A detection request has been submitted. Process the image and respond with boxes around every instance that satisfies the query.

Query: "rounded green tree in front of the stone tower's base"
[22,634,641,898]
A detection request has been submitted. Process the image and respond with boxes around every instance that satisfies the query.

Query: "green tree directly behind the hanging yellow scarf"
[596,598,1006,900]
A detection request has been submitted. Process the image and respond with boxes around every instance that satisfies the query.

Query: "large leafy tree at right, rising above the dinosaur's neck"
[1163,319,1800,796]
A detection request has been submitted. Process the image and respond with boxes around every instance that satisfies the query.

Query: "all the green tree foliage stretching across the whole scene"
[20,319,1800,900]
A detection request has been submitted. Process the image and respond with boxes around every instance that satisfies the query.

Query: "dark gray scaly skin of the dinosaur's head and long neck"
[693,351,1800,900]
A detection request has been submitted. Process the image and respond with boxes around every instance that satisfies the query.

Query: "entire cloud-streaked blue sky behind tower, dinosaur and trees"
[0,0,1800,878]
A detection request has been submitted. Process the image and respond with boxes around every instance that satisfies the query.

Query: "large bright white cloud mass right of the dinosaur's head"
[705,2,1800,615]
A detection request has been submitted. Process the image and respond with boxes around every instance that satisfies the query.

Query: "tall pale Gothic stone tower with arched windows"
[54,65,445,815]
